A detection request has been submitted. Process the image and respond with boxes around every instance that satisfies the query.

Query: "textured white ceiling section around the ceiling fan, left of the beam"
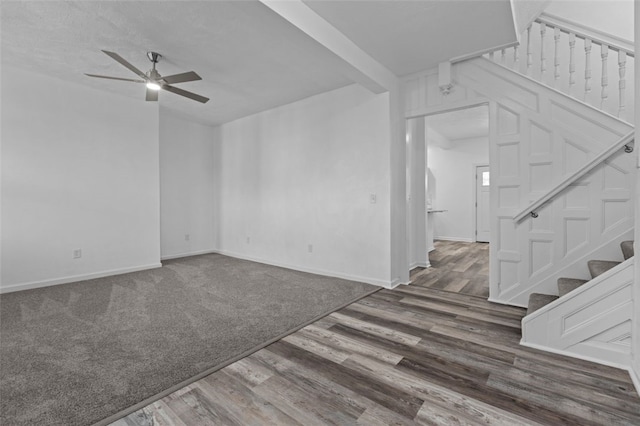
[1,1,351,125]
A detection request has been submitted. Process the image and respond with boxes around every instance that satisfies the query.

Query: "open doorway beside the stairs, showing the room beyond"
[407,102,491,297]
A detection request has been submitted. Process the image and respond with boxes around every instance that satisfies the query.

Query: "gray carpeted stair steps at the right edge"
[527,241,633,315]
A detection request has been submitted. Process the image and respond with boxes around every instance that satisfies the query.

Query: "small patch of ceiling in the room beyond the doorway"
[425,105,489,142]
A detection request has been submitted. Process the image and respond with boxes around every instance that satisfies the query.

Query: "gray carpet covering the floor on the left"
[0,254,378,426]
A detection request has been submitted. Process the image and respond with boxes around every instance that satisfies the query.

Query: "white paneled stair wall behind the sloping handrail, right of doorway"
[453,58,635,306]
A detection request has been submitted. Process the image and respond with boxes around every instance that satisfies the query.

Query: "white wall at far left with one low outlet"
[0,66,160,291]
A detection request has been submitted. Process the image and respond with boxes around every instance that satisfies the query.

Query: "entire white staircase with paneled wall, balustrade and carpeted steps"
[404,8,637,368]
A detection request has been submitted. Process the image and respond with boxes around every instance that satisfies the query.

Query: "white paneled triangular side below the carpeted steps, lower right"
[520,257,634,369]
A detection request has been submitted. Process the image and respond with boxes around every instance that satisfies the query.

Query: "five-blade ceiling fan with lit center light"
[85,50,209,104]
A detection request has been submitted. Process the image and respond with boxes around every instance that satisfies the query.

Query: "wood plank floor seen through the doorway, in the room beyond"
[411,241,489,299]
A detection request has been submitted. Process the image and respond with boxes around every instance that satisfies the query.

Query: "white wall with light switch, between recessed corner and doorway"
[215,85,390,284]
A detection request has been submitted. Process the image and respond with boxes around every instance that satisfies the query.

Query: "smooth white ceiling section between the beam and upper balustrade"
[304,0,517,76]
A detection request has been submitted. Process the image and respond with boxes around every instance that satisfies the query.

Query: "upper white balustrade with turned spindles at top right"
[487,13,635,119]
